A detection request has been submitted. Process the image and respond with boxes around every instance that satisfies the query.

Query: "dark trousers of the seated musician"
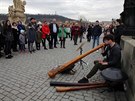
[86,61,108,78]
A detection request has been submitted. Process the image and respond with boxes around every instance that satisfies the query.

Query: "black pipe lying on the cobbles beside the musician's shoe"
[50,81,105,86]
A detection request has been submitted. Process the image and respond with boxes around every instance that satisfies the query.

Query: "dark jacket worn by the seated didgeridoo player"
[102,43,121,68]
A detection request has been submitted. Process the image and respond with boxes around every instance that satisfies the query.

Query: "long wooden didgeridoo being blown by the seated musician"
[48,43,105,78]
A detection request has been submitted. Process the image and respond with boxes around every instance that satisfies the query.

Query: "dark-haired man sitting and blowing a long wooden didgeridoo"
[78,34,121,83]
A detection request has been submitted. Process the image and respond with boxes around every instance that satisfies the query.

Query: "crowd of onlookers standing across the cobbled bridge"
[0,18,123,59]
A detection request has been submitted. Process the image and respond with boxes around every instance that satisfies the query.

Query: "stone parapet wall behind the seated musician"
[121,36,135,101]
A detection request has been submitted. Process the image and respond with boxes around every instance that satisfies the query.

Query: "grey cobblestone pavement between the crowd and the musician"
[0,39,126,101]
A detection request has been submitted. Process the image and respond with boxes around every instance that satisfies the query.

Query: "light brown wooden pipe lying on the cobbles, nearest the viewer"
[56,84,108,92]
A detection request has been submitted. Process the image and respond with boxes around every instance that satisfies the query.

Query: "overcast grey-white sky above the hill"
[0,0,124,21]
